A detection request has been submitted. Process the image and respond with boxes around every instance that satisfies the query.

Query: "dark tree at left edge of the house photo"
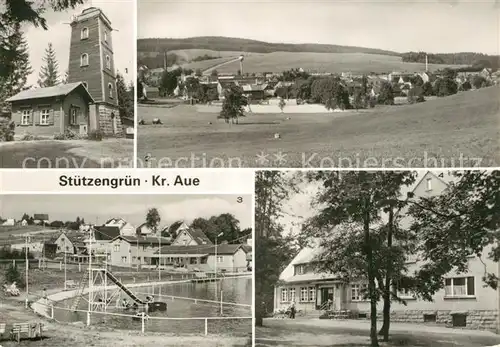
[254,171,294,326]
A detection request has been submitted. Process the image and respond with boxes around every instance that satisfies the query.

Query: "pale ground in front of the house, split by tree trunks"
[255,319,500,347]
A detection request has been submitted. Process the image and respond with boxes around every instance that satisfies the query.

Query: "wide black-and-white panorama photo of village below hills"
[137,0,500,168]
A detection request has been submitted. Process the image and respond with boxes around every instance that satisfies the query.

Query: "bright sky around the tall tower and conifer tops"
[23,0,135,85]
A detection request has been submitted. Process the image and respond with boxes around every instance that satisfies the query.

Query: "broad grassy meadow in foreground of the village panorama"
[137,87,500,168]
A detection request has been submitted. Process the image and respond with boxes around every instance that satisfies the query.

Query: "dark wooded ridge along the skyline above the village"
[137,36,399,56]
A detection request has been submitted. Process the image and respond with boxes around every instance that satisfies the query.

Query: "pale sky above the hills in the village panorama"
[137,0,500,54]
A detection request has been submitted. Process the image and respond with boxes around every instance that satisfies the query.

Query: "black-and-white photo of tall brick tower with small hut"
[0,0,135,169]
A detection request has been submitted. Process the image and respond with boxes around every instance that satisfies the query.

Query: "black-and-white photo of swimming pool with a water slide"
[0,194,253,347]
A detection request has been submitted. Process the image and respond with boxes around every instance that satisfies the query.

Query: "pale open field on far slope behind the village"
[183,52,457,73]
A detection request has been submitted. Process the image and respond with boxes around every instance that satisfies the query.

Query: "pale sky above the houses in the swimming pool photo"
[0,195,253,229]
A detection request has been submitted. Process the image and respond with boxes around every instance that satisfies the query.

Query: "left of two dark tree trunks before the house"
[363,198,379,347]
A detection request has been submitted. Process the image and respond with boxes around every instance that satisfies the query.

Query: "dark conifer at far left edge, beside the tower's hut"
[0,24,32,109]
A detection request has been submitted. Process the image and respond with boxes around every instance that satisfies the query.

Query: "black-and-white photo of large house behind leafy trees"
[255,170,500,347]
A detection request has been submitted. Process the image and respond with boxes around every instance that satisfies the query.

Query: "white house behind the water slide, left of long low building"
[108,235,171,266]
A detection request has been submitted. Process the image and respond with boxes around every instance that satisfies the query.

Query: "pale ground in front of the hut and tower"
[0,139,134,169]
